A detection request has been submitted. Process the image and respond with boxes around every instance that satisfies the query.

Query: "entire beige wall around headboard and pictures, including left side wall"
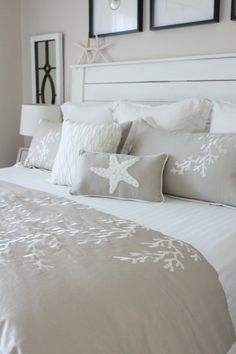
[0,0,236,167]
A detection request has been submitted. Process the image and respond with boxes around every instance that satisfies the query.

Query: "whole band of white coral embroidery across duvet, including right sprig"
[0,184,201,272]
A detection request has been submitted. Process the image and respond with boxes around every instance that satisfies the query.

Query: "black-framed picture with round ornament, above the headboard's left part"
[89,0,143,38]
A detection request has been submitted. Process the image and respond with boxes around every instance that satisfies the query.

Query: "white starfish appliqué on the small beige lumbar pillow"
[90,155,139,194]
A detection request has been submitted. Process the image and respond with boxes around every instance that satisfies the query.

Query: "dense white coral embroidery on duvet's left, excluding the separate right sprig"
[0,196,136,270]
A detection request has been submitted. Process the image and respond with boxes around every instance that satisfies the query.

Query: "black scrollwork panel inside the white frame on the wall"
[34,40,57,104]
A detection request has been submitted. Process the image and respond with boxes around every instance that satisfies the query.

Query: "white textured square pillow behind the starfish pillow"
[51,120,121,186]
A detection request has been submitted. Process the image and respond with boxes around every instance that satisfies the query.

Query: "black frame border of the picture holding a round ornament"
[89,0,143,38]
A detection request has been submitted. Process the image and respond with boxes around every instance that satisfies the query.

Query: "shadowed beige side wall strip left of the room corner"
[0,0,22,167]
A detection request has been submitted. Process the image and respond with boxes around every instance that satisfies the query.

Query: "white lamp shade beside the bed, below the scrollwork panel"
[20,104,61,136]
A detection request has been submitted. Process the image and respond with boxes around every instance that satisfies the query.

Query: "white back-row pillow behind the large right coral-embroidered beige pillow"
[113,98,212,132]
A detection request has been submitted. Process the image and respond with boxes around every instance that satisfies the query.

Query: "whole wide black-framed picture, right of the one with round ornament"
[150,0,220,30]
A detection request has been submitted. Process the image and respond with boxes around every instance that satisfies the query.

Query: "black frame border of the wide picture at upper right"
[150,0,220,31]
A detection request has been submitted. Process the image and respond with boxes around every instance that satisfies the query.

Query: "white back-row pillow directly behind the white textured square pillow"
[61,102,113,124]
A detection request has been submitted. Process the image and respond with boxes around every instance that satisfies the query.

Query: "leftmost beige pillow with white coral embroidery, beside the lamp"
[24,120,62,170]
